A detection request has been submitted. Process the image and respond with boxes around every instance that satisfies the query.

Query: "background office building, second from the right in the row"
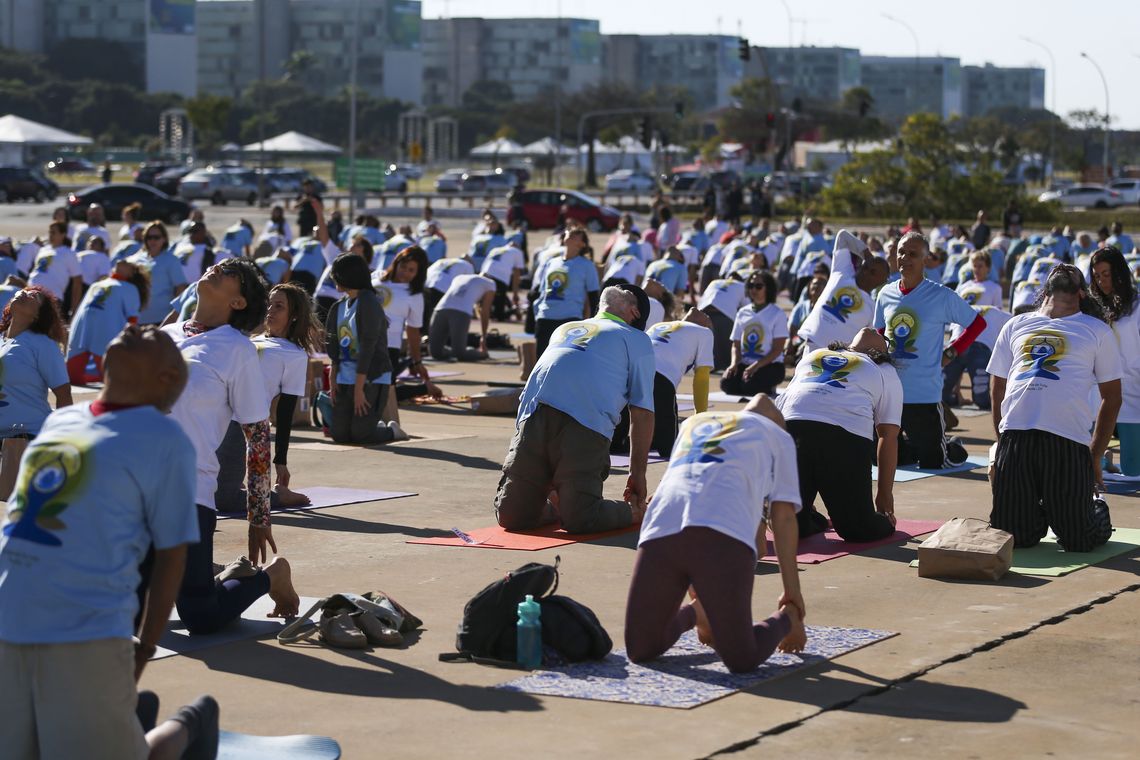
[860,56,962,120]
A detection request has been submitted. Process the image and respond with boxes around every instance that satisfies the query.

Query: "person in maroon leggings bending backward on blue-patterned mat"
[626,395,807,673]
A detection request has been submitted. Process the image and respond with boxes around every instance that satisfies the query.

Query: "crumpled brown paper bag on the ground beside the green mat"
[919,517,1013,581]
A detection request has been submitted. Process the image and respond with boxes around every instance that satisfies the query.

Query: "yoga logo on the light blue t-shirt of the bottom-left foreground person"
[3,441,84,546]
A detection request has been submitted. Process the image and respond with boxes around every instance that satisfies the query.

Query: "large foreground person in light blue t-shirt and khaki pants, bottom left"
[0,326,218,760]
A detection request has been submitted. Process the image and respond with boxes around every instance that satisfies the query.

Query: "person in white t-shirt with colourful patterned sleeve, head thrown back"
[163,259,300,635]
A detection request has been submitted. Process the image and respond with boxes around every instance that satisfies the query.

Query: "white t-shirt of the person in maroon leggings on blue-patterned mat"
[637,411,800,554]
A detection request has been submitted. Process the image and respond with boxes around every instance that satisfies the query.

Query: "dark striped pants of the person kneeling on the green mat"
[990,430,1113,551]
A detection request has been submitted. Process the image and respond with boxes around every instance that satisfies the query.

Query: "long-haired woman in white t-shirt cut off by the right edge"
[1089,247,1140,477]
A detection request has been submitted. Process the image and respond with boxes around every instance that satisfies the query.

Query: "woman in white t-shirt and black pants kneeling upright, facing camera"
[720,271,788,395]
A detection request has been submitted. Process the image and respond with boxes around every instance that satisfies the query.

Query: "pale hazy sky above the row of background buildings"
[423,0,1140,129]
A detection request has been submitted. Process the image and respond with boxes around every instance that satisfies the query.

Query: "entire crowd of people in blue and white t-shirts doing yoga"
[0,186,1140,757]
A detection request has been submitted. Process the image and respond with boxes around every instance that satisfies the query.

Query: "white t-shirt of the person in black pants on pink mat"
[776,349,903,441]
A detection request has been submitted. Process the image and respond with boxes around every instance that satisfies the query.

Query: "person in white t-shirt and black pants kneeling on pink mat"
[776,327,903,541]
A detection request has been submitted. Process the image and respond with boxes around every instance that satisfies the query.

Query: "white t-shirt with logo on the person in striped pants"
[986,311,1124,446]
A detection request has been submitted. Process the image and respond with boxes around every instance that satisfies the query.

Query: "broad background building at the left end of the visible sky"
[423,18,602,107]
